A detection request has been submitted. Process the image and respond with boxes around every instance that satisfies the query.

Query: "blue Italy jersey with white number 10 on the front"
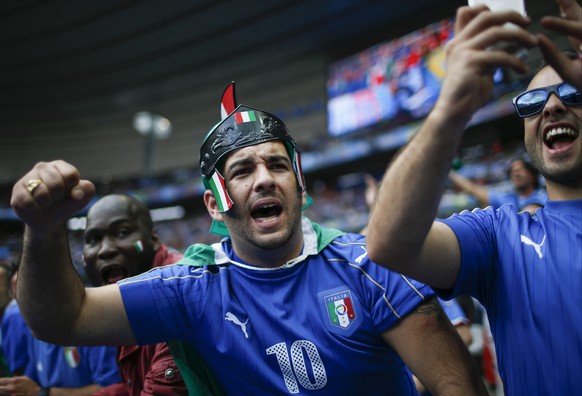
[119,219,433,395]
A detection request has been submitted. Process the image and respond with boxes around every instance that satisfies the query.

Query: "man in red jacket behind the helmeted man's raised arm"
[83,194,217,396]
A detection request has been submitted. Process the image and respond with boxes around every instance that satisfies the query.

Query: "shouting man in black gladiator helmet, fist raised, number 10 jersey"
[12,105,487,396]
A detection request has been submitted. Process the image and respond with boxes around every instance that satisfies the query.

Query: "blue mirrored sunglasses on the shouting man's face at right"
[513,83,582,118]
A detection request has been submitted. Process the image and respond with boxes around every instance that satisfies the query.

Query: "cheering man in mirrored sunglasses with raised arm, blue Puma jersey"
[367,0,582,395]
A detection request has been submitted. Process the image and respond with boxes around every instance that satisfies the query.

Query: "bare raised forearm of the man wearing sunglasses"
[368,111,468,265]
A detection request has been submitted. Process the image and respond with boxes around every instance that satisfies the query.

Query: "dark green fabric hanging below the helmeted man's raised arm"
[168,341,225,396]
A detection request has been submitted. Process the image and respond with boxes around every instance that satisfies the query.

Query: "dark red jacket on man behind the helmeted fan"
[95,245,188,396]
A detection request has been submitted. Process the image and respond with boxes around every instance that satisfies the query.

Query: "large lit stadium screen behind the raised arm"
[327,18,509,136]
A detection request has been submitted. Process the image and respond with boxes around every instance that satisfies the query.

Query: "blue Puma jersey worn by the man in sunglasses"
[440,201,582,396]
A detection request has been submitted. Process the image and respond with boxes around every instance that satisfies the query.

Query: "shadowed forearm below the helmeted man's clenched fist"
[17,226,85,343]
